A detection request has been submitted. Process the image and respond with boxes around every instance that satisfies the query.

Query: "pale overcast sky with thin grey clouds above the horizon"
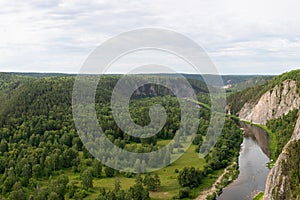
[0,0,300,74]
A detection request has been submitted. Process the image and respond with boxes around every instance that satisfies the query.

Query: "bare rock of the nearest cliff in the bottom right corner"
[264,117,300,200]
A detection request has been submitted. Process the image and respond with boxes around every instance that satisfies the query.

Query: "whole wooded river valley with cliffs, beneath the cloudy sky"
[0,70,300,200]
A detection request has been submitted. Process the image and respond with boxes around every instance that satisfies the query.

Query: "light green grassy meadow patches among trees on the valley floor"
[64,140,218,199]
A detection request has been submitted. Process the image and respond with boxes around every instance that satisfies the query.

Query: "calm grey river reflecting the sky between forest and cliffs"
[217,123,270,200]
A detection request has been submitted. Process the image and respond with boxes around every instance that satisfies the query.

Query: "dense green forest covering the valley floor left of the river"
[0,73,242,199]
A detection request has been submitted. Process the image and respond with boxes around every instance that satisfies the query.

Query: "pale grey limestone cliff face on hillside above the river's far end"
[239,80,300,124]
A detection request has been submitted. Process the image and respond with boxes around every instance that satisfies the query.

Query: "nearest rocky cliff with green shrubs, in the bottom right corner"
[264,117,300,200]
